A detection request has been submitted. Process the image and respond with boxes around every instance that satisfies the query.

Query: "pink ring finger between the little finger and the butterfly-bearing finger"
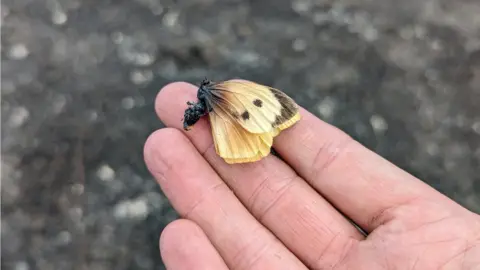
[144,128,305,269]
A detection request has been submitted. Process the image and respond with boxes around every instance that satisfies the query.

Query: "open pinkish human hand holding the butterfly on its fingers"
[144,82,480,270]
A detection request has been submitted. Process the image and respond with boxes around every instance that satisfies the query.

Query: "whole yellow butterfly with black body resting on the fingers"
[183,79,301,164]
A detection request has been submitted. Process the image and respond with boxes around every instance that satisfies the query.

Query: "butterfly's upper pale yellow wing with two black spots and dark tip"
[211,80,300,136]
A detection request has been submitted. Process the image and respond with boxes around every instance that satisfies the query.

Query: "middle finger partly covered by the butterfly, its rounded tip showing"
[156,83,363,268]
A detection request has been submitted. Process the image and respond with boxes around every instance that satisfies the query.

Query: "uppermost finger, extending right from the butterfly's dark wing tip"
[274,104,468,232]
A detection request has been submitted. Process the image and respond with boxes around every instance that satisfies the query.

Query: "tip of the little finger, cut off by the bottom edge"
[160,219,228,270]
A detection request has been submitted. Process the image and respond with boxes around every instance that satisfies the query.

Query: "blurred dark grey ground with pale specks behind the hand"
[1,0,480,270]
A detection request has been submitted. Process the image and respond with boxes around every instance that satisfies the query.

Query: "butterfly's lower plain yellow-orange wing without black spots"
[209,106,276,164]
